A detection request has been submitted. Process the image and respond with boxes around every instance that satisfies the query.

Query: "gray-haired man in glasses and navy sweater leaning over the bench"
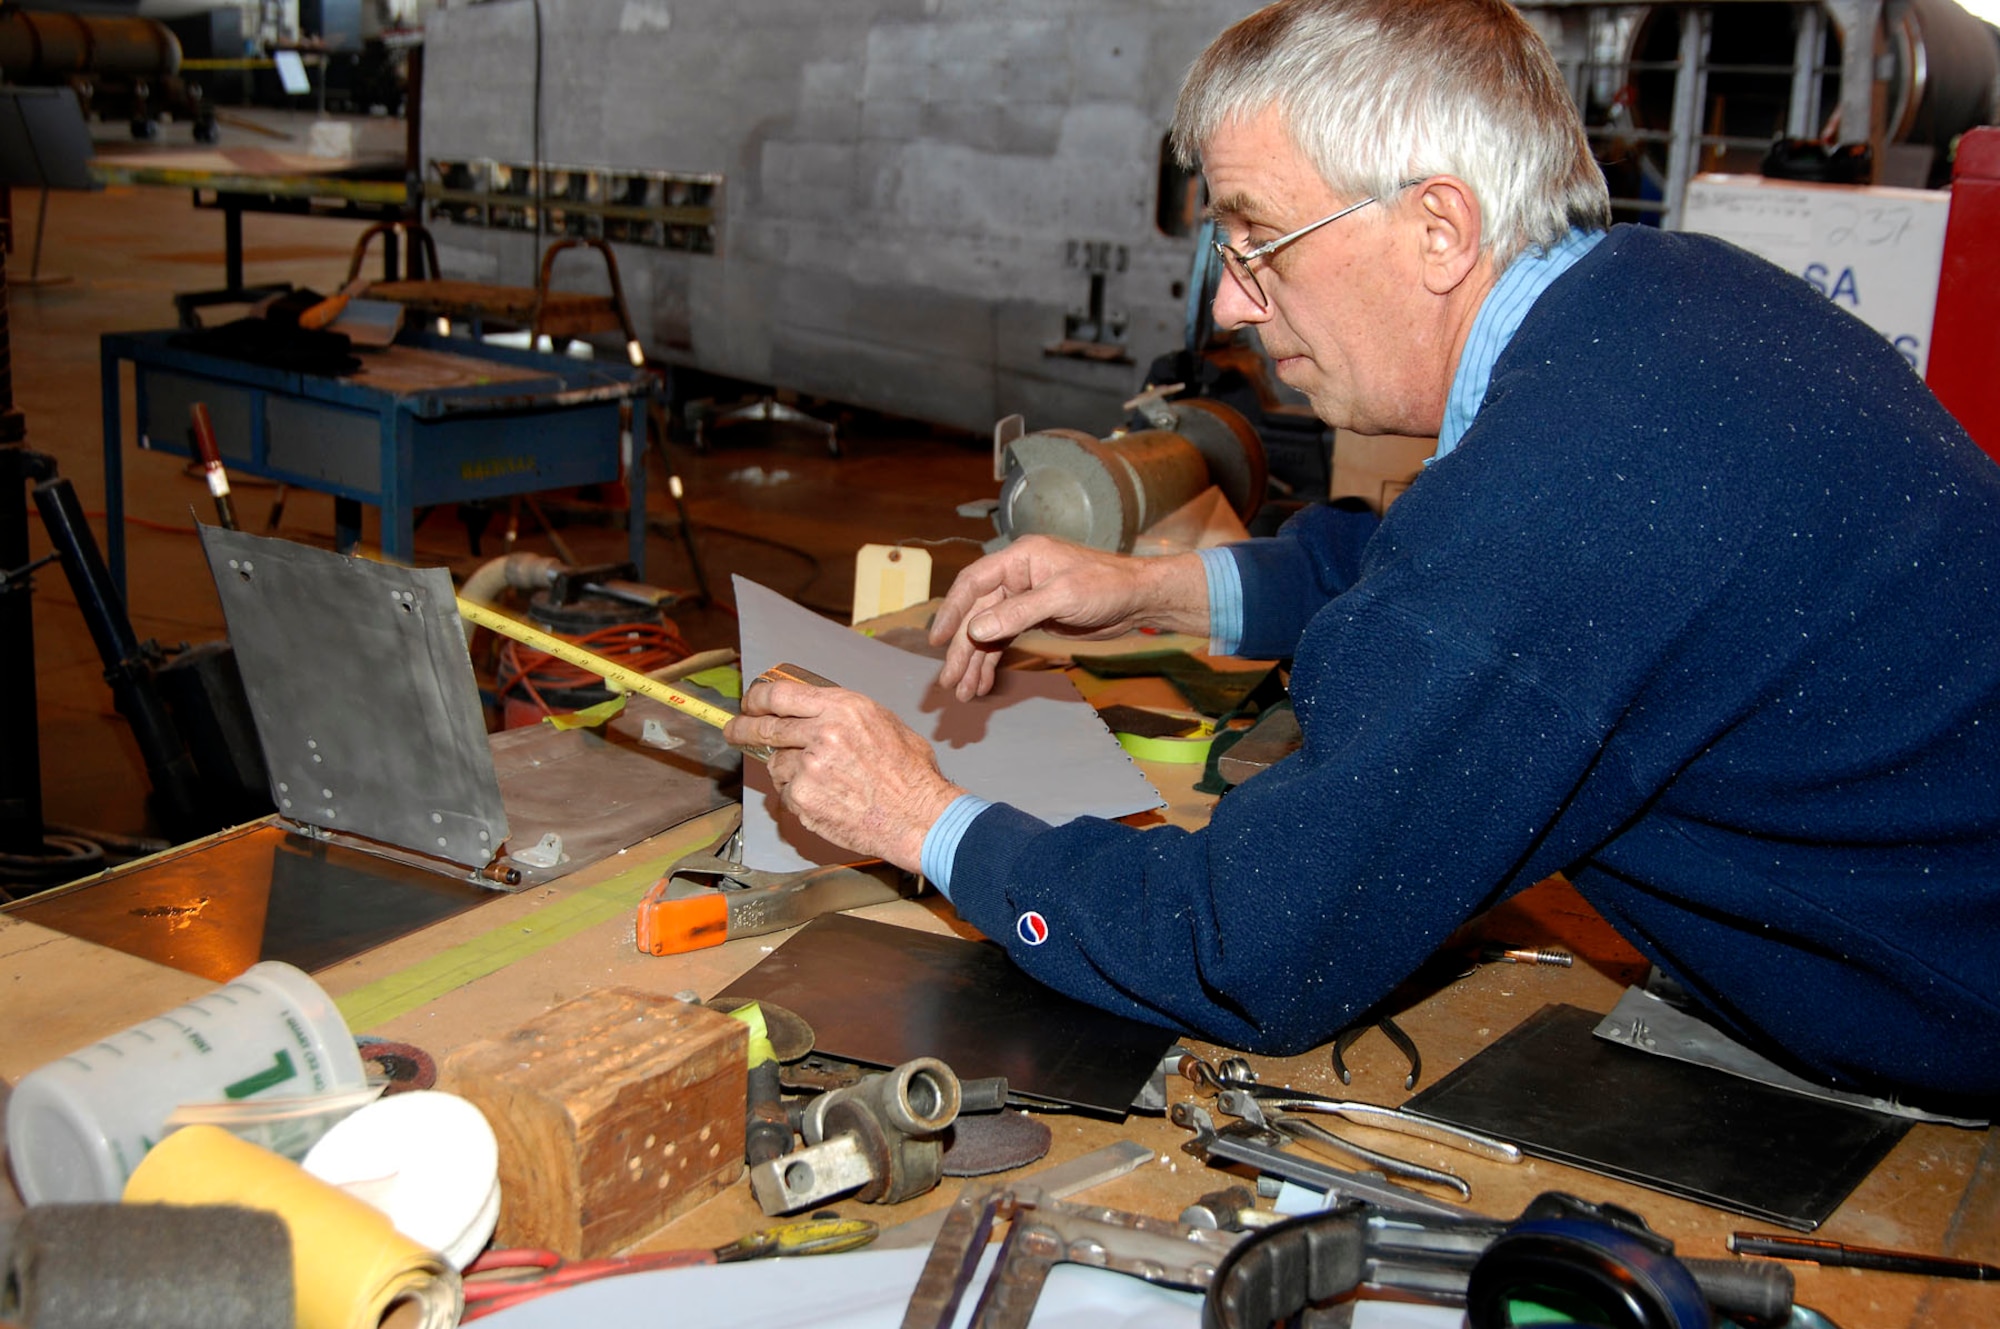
[730,0,2000,1105]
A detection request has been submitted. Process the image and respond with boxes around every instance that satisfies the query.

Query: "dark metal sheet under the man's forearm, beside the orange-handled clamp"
[716,915,1178,1117]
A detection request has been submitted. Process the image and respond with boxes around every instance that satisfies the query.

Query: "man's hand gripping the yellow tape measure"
[722,679,964,873]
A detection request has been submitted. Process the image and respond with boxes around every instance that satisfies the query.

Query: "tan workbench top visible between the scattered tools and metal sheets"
[0,632,2000,1329]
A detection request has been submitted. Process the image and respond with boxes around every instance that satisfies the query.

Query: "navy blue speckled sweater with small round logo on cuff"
[952,226,2000,1101]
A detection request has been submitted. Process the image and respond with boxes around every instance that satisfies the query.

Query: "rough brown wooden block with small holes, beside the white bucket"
[438,987,748,1259]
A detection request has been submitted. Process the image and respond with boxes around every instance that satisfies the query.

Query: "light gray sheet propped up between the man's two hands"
[736,576,1164,873]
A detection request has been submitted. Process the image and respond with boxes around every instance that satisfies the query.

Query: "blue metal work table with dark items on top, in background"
[100,332,654,594]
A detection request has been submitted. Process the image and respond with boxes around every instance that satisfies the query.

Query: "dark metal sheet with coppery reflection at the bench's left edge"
[6,821,498,983]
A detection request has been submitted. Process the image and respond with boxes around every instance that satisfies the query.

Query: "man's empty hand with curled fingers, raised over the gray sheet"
[930,534,1208,701]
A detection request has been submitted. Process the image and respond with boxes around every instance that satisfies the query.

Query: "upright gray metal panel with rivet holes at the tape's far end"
[200,526,508,871]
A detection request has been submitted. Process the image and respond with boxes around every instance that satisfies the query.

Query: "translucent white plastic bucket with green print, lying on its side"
[6,961,368,1205]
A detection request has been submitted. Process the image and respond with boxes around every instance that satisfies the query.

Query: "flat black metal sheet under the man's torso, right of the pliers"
[1404,1005,1910,1231]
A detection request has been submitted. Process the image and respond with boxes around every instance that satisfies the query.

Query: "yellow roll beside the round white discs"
[124,1127,464,1329]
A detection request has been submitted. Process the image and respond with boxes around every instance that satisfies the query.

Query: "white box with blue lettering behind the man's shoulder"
[1682,176,1952,374]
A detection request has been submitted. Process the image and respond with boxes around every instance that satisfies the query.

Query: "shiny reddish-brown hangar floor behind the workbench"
[0,111,996,852]
